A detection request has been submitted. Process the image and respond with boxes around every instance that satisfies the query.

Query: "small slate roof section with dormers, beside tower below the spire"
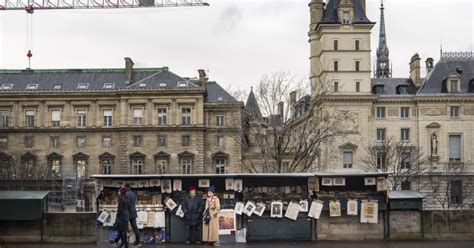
[371,78,417,96]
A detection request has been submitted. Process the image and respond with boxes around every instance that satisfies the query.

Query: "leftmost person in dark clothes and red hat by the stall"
[114,186,130,248]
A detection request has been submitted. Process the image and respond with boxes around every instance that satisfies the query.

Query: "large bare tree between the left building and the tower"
[231,72,350,173]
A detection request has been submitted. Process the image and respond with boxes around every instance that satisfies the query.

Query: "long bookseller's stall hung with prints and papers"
[92,173,388,243]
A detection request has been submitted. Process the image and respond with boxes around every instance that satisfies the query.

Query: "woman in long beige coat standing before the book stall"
[202,186,221,246]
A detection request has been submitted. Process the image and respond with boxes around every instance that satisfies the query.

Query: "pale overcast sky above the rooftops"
[0,0,474,93]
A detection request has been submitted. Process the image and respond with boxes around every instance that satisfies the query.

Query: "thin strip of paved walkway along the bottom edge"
[0,241,474,248]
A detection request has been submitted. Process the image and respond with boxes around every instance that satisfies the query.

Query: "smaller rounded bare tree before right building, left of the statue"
[361,137,428,190]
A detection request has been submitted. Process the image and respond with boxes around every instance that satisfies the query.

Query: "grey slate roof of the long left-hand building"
[0,67,236,102]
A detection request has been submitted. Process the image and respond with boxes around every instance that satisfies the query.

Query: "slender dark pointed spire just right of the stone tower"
[375,0,392,78]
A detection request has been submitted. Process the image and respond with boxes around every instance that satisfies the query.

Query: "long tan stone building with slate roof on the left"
[0,58,243,207]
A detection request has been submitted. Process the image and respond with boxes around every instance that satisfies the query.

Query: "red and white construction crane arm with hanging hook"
[0,0,209,68]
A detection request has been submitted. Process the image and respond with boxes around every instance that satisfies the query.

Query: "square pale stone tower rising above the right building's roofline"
[308,0,374,95]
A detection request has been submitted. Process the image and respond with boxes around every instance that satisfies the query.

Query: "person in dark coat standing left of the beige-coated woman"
[181,186,204,244]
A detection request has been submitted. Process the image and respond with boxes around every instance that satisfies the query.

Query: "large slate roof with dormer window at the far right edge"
[417,57,474,95]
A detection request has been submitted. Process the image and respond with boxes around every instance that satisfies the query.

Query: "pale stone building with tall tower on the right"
[308,0,474,208]
